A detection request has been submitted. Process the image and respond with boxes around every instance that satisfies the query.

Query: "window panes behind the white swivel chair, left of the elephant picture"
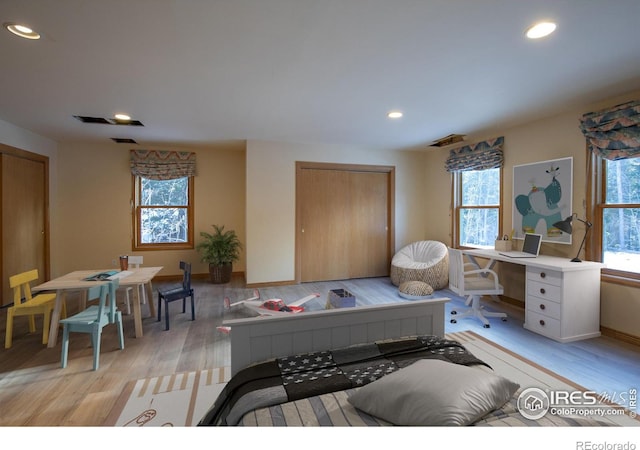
[453,168,502,247]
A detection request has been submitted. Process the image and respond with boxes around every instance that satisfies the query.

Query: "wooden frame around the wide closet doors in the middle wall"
[295,161,396,284]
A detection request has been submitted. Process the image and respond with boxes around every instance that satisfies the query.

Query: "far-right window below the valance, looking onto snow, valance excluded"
[591,154,640,281]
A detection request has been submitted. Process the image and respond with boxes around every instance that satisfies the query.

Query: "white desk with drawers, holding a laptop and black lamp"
[463,249,605,342]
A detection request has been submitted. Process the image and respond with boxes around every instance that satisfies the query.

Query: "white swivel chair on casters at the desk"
[449,248,507,328]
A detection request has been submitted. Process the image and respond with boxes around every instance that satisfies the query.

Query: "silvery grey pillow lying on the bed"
[349,359,520,426]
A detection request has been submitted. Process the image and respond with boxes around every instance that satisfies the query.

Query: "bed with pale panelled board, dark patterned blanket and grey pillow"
[199,298,616,426]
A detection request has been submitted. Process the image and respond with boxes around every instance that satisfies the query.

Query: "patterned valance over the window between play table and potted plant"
[130,150,196,180]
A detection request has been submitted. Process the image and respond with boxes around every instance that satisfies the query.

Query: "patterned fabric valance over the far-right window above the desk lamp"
[580,100,640,160]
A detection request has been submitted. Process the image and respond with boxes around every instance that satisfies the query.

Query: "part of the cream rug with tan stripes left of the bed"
[105,367,231,427]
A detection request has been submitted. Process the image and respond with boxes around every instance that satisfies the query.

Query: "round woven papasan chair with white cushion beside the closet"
[390,241,449,290]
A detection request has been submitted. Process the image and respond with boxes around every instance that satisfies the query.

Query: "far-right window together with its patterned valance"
[580,100,640,286]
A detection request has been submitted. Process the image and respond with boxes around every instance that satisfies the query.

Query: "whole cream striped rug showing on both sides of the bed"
[105,331,640,427]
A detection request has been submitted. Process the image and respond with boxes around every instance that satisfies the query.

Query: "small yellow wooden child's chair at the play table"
[4,269,67,348]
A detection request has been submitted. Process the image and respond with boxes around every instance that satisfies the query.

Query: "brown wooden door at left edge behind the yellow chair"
[1,150,48,305]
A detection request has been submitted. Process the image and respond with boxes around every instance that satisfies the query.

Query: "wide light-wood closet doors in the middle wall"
[296,163,393,282]
